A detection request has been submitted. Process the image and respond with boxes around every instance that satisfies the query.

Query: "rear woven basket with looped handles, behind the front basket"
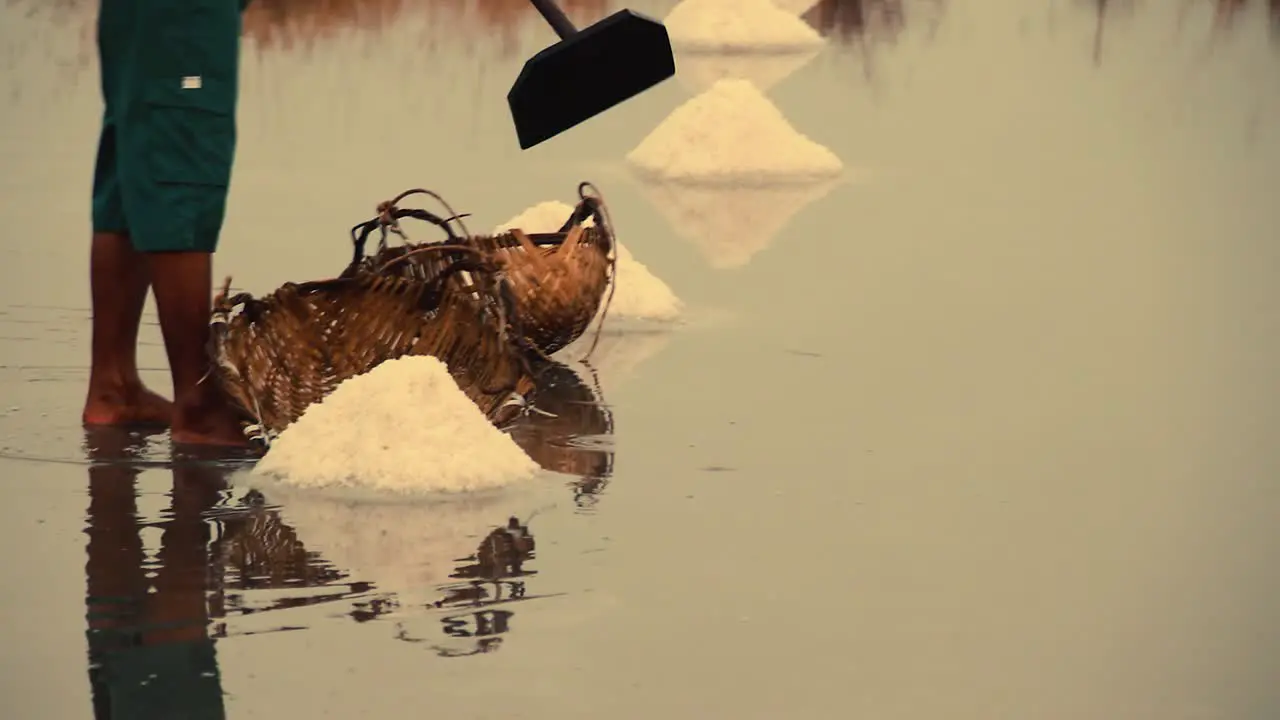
[343,183,614,356]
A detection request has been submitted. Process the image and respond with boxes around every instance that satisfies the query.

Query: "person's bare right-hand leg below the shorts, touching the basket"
[146,252,247,446]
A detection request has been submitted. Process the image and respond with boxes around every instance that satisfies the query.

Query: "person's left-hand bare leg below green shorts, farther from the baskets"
[81,233,173,425]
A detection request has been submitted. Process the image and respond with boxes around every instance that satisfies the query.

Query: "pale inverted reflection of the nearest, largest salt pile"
[262,487,534,605]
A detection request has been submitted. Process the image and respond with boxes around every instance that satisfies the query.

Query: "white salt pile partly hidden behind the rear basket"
[494,200,681,320]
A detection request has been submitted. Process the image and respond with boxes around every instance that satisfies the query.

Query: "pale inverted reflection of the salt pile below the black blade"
[640,179,836,269]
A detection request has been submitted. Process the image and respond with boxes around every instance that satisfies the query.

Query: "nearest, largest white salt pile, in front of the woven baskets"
[255,356,538,493]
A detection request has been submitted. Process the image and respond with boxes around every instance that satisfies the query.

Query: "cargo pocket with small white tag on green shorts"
[145,77,236,187]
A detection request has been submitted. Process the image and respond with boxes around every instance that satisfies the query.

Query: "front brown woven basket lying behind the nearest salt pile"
[210,261,534,442]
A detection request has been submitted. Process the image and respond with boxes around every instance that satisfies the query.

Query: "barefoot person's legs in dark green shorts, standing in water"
[82,0,246,445]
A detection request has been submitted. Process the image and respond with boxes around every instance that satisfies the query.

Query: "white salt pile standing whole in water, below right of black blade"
[627,79,844,184]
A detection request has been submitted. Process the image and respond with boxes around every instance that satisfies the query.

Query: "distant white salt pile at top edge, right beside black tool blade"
[663,0,823,53]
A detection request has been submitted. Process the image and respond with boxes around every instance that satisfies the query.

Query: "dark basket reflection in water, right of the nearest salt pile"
[511,363,613,482]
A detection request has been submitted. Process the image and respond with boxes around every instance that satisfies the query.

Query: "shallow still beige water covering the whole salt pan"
[0,0,1280,720]
